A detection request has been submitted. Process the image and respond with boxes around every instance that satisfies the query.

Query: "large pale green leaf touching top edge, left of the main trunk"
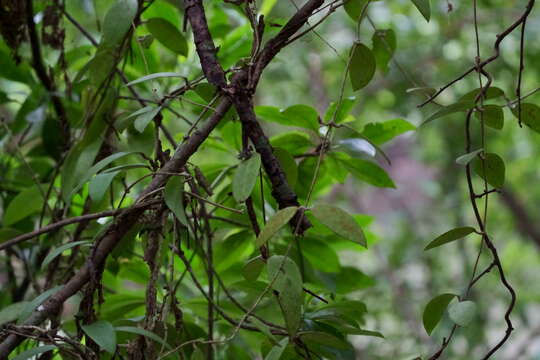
[103,0,138,45]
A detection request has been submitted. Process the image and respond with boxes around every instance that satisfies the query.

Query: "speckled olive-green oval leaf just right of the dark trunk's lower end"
[311,204,367,247]
